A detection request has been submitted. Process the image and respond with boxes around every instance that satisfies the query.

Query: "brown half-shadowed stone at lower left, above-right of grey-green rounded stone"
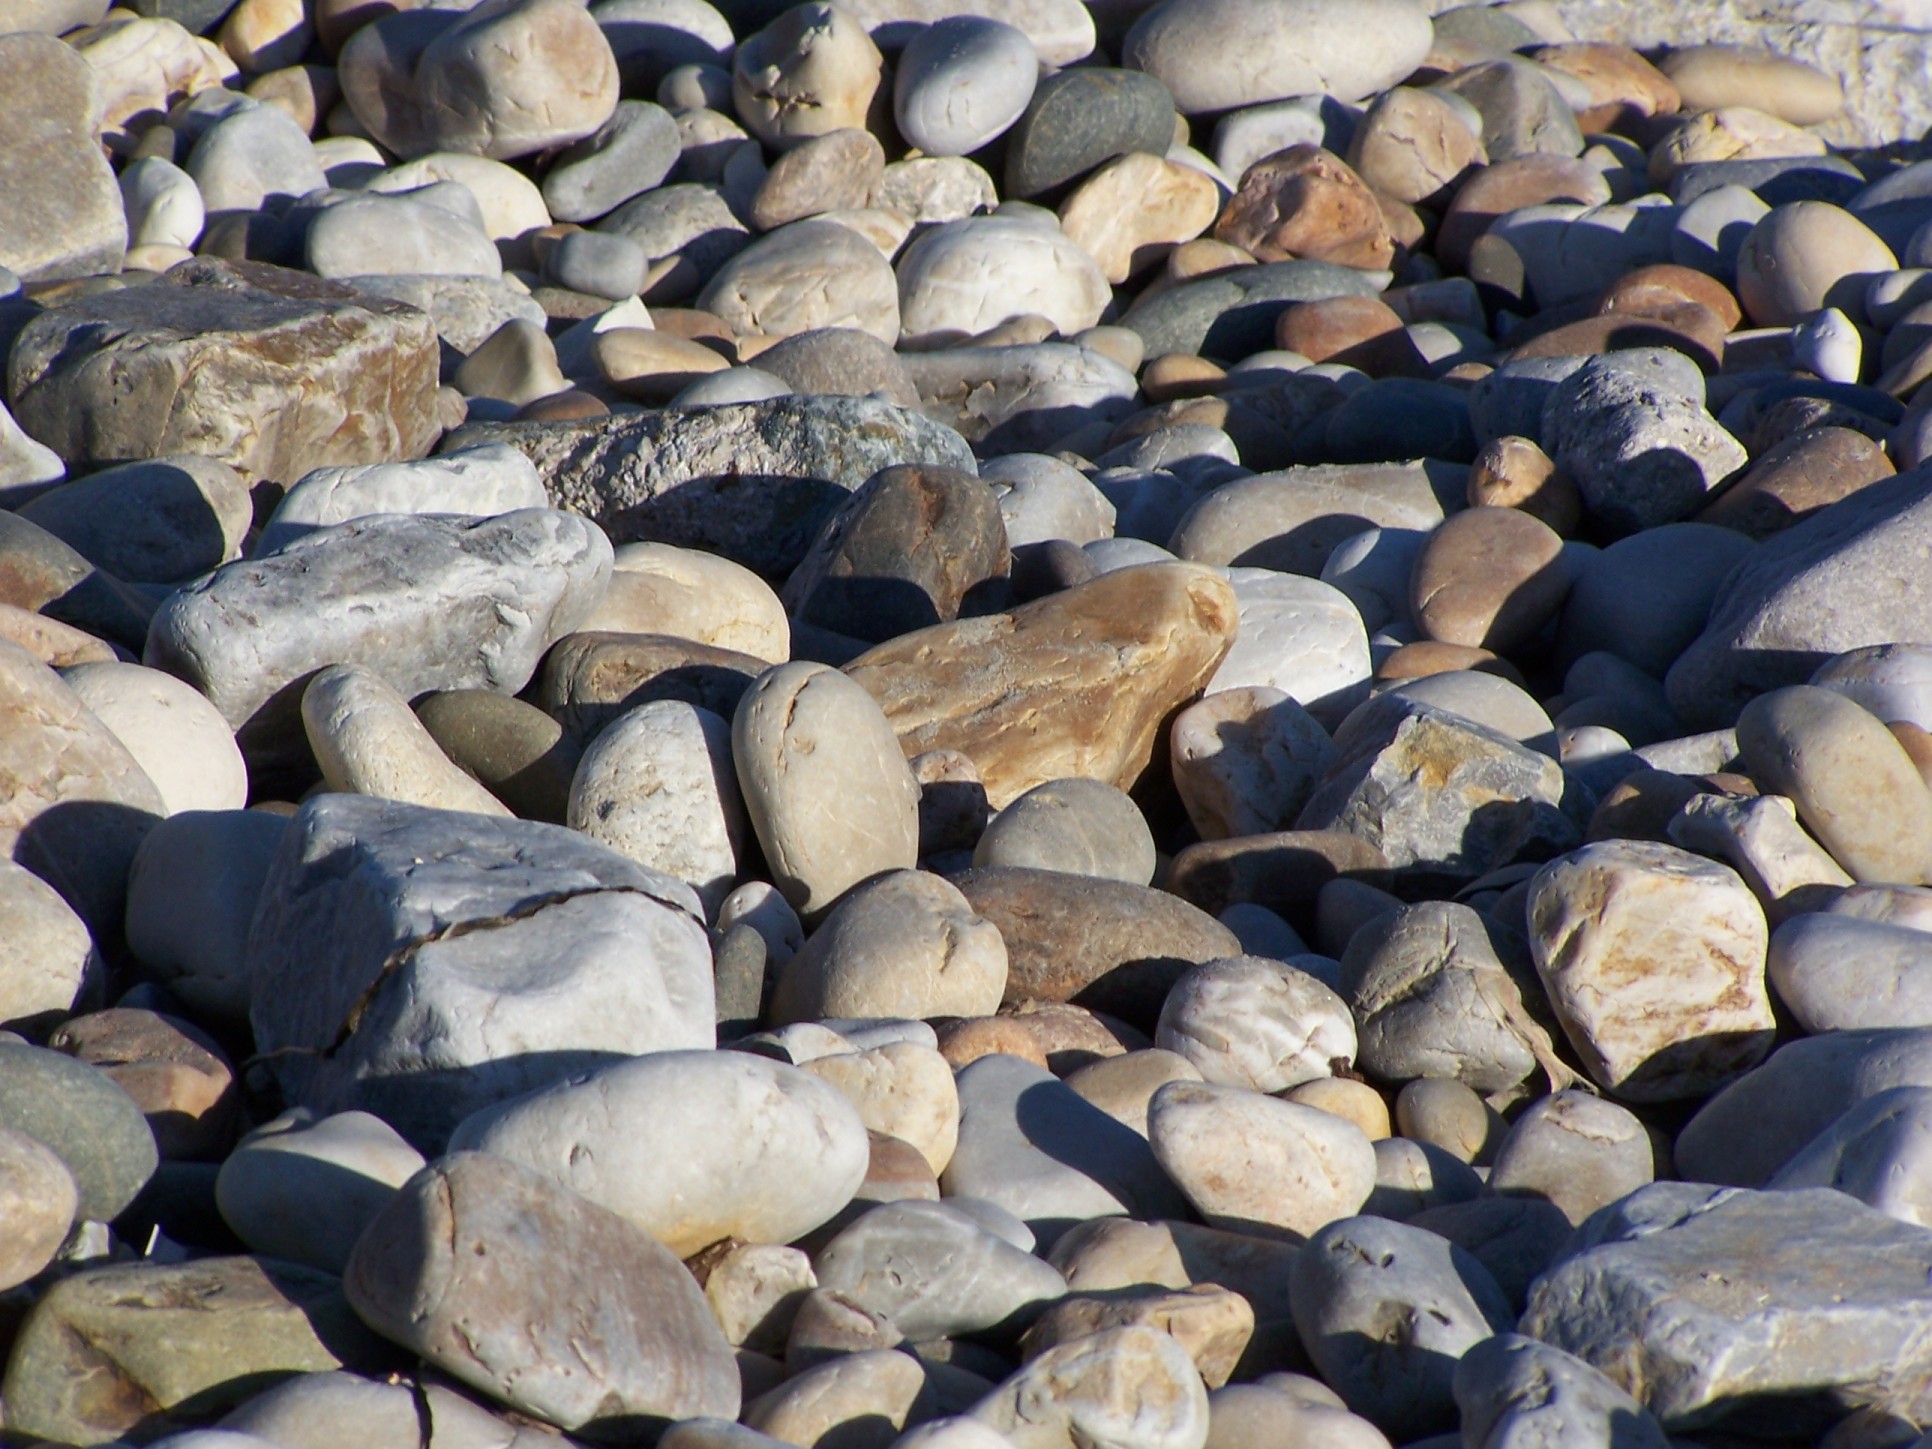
[46,1007,240,1161]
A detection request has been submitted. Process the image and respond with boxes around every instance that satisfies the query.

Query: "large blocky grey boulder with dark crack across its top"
[247,794,715,1150]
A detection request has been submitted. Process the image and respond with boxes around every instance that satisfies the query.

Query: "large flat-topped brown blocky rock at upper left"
[8,259,440,483]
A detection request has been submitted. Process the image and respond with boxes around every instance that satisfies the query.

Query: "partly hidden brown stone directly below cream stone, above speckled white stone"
[531,630,767,742]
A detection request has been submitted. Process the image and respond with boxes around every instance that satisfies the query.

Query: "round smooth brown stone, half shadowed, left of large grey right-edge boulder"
[1408,508,1571,653]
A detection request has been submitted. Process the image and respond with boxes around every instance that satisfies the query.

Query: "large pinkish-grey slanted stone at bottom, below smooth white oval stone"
[342,1151,740,1434]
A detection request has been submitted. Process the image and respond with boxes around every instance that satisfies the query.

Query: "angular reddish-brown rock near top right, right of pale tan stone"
[1213,145,1395,269]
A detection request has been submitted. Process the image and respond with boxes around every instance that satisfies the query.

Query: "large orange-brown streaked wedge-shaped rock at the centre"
[846,564,1238,811]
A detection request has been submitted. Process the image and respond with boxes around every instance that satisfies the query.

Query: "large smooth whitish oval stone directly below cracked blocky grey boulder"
[450,1051,866,1258]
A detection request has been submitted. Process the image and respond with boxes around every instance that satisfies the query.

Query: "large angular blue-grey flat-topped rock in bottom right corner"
[1520,1182,1932,1437]
